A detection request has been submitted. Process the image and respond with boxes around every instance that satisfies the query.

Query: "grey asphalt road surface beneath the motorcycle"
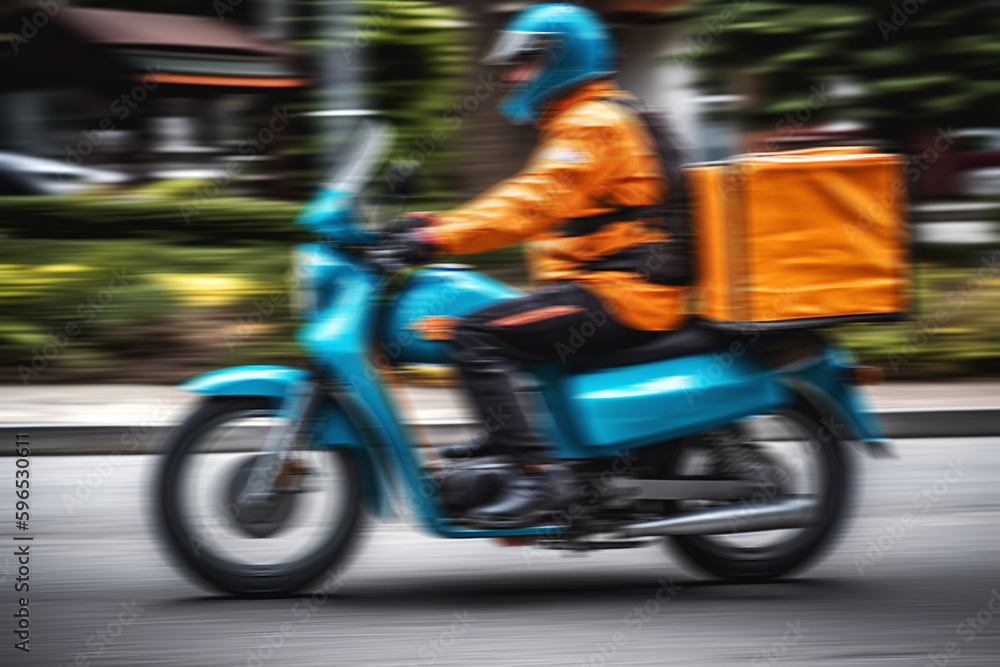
[0,438,1000,667]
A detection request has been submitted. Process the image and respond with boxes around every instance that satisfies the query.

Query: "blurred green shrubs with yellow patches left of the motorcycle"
[0,237,298,384]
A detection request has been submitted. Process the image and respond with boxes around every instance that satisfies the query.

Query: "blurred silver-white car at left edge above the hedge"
[0,153,130,195]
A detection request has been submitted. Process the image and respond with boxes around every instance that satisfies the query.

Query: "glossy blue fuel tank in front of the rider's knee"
[380,266,521,364]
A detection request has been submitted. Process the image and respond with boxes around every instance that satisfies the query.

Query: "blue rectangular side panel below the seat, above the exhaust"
[561,354,793,456]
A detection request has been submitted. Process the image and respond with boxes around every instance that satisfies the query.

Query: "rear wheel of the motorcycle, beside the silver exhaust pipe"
[668,403,850,582]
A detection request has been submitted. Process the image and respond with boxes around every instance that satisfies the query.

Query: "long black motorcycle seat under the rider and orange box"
[568,318,819,372]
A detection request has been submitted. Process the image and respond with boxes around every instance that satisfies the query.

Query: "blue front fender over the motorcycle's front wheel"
[177,364,386,516]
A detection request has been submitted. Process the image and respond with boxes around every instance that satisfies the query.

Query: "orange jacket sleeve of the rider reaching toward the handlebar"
[430,114,621,254]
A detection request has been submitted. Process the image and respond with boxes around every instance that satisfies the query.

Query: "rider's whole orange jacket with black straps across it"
[427,81,686,331]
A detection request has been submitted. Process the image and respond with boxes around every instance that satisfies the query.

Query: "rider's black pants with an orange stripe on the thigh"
[454,283,656,465]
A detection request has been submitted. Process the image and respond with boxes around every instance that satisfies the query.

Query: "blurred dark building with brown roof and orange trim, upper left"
[0,3,308,190]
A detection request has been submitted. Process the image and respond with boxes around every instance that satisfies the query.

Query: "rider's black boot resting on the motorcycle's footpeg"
[462,463,580,528]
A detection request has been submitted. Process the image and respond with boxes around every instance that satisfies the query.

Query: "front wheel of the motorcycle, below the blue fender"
[155,396,362,596]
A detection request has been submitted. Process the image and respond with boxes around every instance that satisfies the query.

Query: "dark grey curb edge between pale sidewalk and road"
[0,408,1000,456]
